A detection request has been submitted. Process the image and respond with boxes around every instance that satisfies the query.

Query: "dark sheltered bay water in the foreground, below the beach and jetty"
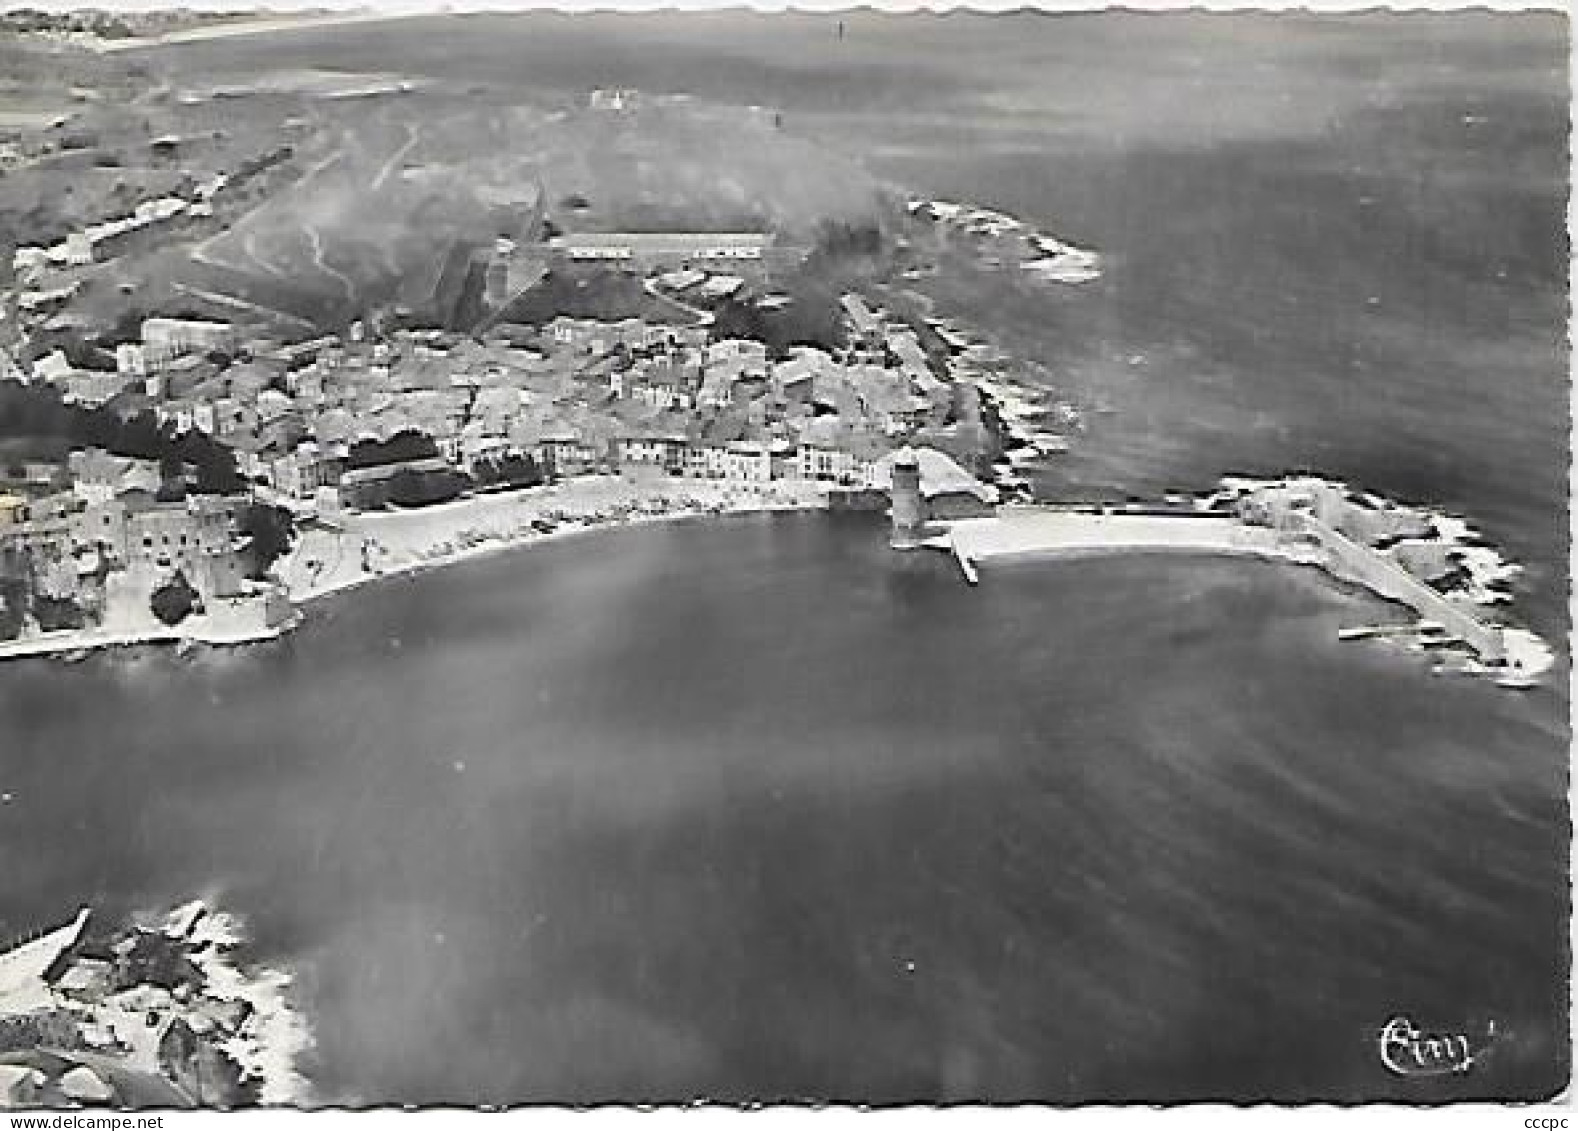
[0,516,1564,1101]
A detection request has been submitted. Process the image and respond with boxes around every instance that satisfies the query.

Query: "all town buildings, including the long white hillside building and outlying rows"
[0,144,1009,640]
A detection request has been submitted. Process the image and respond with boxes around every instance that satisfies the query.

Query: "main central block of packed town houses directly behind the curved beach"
[12,276,980,508]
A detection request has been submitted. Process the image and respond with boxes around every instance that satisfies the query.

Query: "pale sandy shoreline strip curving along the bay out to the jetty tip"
[0,476,1554,686]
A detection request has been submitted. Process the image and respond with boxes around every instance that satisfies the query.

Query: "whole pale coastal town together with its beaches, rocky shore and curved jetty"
[0,57,1548,683]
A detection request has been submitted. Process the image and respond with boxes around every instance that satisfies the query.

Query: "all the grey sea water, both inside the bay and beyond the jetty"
[0,8,1567,1103]
